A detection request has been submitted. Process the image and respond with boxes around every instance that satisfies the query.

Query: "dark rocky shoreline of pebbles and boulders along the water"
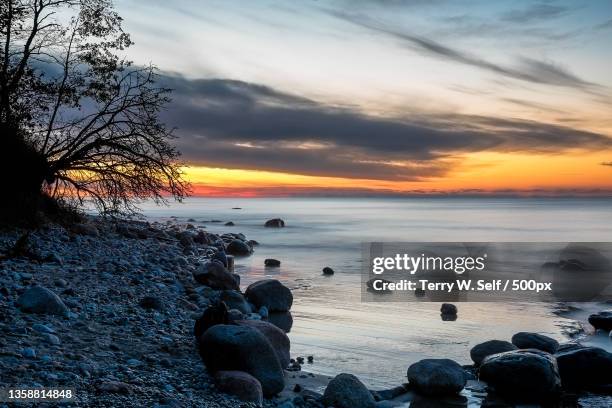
[0,217,612,408]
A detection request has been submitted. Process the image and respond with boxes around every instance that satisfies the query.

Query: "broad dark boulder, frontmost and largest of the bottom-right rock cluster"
[479,349,561,402]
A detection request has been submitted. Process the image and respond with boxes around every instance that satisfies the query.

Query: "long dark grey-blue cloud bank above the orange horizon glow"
[162,76,612,180]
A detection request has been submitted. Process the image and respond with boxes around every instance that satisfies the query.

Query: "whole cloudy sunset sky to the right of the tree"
[115,0,612,196]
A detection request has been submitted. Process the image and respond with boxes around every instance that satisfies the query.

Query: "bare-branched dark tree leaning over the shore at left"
[0,0,189,222]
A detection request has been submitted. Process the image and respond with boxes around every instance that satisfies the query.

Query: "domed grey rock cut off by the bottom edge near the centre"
[321,373,376,408]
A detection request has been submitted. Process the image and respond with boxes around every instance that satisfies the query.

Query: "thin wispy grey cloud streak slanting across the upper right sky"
[329,10,596,89]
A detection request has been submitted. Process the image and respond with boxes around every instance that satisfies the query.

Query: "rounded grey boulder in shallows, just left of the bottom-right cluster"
[408,358,467,396]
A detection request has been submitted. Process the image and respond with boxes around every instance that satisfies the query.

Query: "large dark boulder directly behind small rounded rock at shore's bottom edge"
[198,324,285,397]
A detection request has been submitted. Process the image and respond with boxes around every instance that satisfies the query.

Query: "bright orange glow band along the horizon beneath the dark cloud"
[184,151,612,197]
